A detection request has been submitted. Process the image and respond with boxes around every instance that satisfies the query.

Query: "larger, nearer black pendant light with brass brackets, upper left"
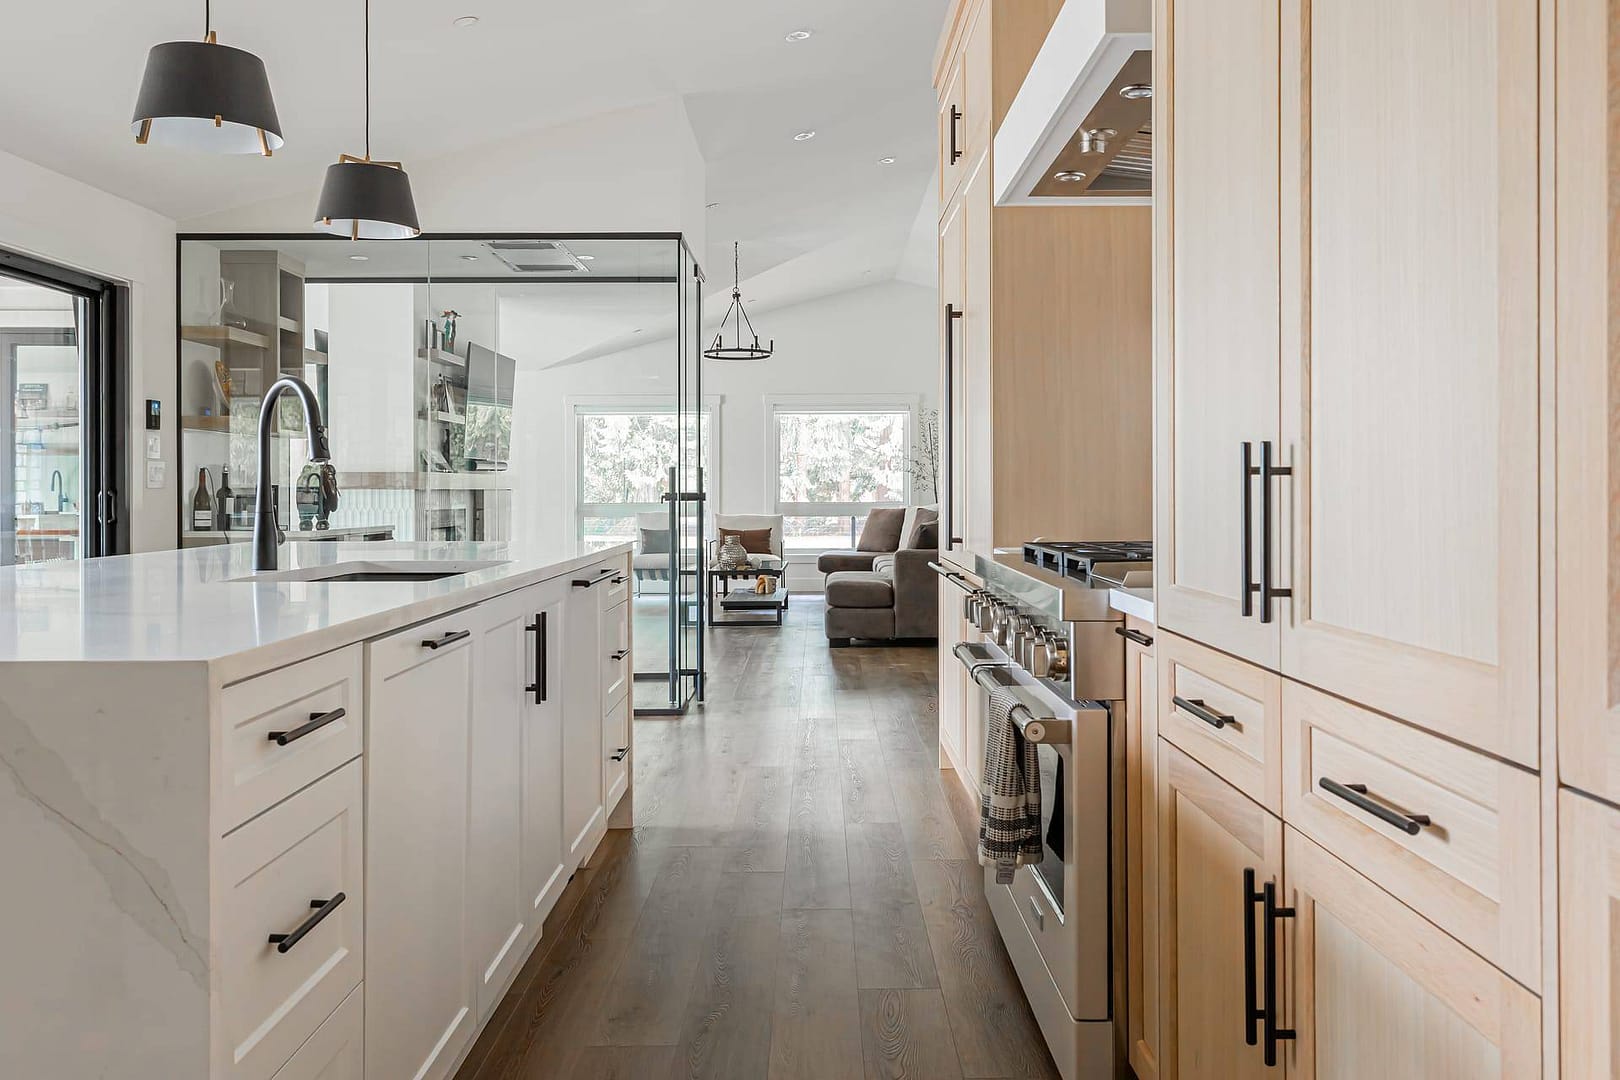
[130,0,282,157]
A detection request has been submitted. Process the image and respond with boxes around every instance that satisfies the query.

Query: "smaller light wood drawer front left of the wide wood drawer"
[1155,633,1283,814]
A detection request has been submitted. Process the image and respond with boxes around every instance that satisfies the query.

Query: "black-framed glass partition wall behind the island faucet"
[177,233,710,712]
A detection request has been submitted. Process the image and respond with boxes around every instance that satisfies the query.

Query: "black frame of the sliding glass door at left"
[0,248,133,559]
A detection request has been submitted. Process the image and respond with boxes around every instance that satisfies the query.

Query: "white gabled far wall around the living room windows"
[501,282,940,582]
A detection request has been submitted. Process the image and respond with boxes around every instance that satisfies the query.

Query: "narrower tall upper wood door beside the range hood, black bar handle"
[1153,0,1286,669]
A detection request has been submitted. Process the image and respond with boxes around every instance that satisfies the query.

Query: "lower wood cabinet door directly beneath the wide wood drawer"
[1283,827,1535,1080]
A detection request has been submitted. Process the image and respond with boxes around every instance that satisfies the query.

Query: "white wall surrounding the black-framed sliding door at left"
[0,145,181,551]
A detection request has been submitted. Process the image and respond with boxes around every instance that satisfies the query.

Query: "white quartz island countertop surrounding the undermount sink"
[0,541,632,677]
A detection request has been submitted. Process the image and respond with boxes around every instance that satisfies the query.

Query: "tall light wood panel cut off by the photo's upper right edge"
[1555,0,1620,801]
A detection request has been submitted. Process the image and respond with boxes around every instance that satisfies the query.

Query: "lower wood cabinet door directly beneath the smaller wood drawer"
[1158,740,1283,1080]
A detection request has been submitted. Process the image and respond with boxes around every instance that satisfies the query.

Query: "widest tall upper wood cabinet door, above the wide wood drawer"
[1276,0,1542,767]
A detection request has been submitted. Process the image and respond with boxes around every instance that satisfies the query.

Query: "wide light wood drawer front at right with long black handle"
[1283,680,1541,989]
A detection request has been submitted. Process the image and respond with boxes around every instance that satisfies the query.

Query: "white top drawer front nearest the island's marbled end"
[215,644,365,834]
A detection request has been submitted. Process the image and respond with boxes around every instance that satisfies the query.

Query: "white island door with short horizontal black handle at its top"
[365,609,481,1080]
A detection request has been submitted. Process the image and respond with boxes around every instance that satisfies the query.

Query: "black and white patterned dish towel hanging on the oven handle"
[978,687,1042,884]
